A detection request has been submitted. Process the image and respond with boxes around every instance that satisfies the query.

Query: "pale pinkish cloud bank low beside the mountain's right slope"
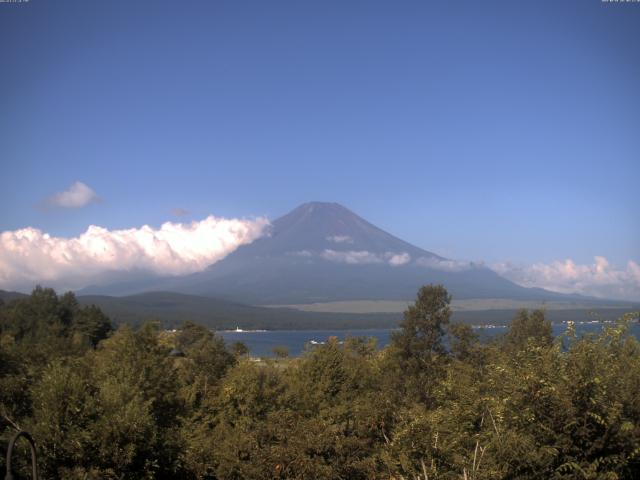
[492,257,640,301]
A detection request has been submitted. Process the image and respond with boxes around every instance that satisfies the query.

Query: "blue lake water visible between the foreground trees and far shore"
[216,322,640,357]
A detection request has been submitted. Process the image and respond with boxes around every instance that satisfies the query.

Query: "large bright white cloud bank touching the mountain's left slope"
[0,216,269,289]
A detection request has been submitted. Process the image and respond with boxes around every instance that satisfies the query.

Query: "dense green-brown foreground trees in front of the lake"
[0,286,640,480]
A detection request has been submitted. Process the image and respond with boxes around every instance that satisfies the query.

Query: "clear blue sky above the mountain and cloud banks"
[0,0,640,298]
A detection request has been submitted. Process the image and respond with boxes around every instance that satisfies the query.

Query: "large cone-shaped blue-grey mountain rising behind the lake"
[150,202,570,305]
